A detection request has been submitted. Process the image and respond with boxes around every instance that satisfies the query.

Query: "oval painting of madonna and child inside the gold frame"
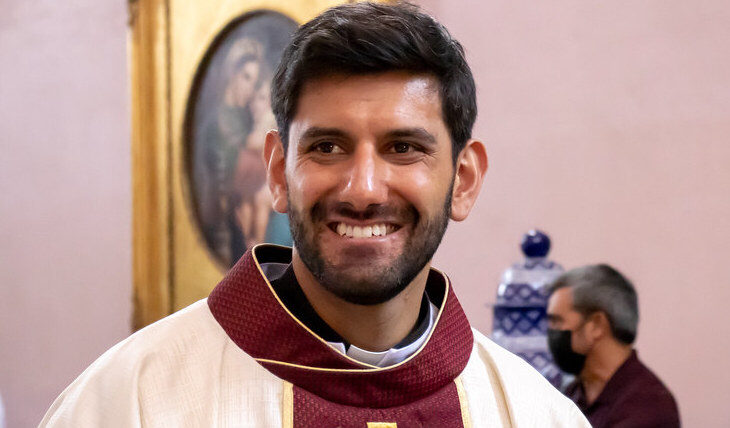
[184,11,297,268]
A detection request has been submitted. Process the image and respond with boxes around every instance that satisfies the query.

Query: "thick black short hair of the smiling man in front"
[271,2,477,162]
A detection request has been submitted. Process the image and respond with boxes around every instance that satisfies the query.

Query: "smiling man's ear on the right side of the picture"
[451,140,488,221]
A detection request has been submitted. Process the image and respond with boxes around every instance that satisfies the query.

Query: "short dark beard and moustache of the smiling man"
[288,180,454,305]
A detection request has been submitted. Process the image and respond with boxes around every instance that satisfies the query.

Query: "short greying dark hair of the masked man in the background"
[550,264,639,345]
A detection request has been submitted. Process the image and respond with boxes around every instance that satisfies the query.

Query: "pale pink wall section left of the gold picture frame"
[0,0,131,428]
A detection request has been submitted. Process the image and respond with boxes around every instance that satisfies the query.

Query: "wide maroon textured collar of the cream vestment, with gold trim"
[208,245,474,408]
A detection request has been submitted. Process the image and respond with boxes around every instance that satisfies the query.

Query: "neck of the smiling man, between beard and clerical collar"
[292,251,430,351]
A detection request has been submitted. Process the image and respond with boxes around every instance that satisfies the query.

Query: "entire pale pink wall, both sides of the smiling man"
[0,0,730,427]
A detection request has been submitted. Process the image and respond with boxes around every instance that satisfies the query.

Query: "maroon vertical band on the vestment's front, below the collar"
[294,382,463,428]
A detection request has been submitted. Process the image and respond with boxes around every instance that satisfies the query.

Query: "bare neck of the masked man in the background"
[580,339,632,405]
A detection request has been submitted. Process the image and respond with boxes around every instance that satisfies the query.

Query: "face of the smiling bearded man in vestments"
[286,72,454,304]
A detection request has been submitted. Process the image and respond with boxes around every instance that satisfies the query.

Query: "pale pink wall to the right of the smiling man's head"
[420,0,730,427]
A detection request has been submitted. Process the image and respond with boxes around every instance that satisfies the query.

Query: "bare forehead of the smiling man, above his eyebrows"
[290,71,448,139]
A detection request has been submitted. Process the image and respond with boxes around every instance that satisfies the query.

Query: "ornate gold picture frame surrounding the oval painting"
[129,0,364,330]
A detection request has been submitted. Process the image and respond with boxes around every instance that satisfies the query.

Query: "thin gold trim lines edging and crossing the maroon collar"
[251,244,451,373]
